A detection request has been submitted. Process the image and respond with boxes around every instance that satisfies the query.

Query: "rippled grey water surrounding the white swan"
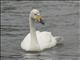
[1,1,80,60]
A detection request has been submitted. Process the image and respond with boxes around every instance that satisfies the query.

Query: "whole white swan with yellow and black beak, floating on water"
[21,9,60,51]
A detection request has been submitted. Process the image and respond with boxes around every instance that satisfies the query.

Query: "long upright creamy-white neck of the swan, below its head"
[29,17,40,50]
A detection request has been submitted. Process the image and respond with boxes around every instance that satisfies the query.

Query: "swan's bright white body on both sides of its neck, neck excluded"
[21,31,57,51]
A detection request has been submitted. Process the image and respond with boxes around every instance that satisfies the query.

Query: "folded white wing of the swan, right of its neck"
[37,31,56,50]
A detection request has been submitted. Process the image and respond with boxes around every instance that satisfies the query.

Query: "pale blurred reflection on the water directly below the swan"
[23,52,55,60]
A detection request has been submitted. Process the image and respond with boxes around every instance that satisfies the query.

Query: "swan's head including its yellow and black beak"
[30,9,44,24]
